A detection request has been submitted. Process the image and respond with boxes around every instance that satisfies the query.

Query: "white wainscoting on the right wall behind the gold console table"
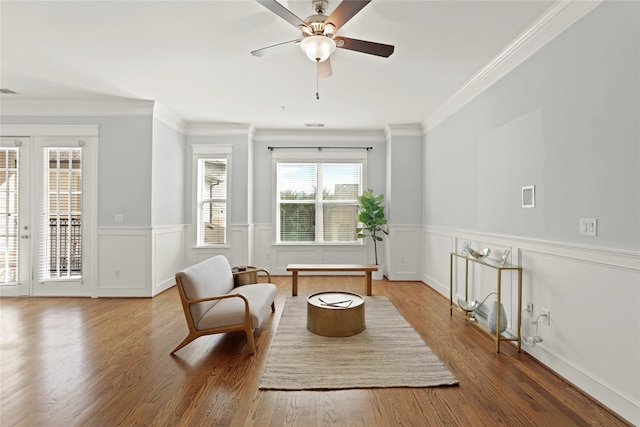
[422,227,640,424]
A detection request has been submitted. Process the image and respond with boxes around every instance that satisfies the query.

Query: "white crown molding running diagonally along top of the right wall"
[422,0,604,132]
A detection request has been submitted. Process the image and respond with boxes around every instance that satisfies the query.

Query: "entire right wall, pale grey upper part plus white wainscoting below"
[422,1,640,424]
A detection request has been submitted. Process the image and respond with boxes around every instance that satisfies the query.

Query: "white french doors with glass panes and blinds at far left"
[0,129,97,296]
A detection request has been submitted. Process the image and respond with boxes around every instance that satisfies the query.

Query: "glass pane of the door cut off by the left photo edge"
[0,147,20,285]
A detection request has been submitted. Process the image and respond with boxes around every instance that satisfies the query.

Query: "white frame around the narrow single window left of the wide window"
[191,144,233,248]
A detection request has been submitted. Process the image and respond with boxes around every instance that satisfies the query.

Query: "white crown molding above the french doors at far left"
[0,95,154,117]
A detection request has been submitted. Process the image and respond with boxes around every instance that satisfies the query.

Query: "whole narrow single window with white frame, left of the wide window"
[194,146,231,246]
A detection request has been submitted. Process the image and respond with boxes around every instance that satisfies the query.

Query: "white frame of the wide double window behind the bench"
[272,149,367,246]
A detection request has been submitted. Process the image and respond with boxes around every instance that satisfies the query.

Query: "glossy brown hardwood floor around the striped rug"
[0,276,630,427]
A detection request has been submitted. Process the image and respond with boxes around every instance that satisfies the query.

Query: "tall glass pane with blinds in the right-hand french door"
[40,147,82,280]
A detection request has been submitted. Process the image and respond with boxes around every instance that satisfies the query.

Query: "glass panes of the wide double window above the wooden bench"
[276,161,363,243]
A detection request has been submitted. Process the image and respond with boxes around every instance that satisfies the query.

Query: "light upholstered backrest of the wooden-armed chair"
[176,255,233,325]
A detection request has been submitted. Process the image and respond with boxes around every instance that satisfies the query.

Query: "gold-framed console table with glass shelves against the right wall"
[449,252,522,353]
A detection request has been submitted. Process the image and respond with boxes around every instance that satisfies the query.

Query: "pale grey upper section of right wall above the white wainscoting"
[423,1,640,251]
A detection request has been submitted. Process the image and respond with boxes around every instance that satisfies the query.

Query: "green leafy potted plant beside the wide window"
[356,190,389,280]
